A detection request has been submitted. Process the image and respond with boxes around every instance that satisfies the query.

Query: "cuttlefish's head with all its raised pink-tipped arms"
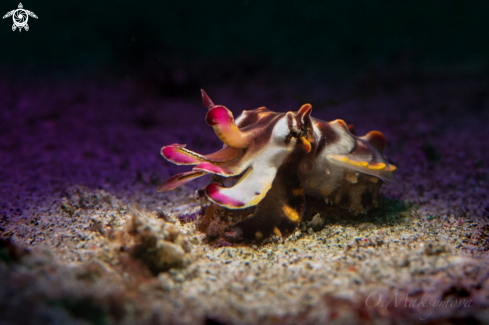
[158,90,312,209]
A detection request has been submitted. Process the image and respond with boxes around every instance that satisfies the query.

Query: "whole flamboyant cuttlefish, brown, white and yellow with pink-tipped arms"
[158,90,396,238]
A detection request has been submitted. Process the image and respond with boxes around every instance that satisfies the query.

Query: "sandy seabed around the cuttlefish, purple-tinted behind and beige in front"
[0,77,489,324]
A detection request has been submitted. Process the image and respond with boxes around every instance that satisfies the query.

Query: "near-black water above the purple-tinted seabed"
[0,0,489,83]
